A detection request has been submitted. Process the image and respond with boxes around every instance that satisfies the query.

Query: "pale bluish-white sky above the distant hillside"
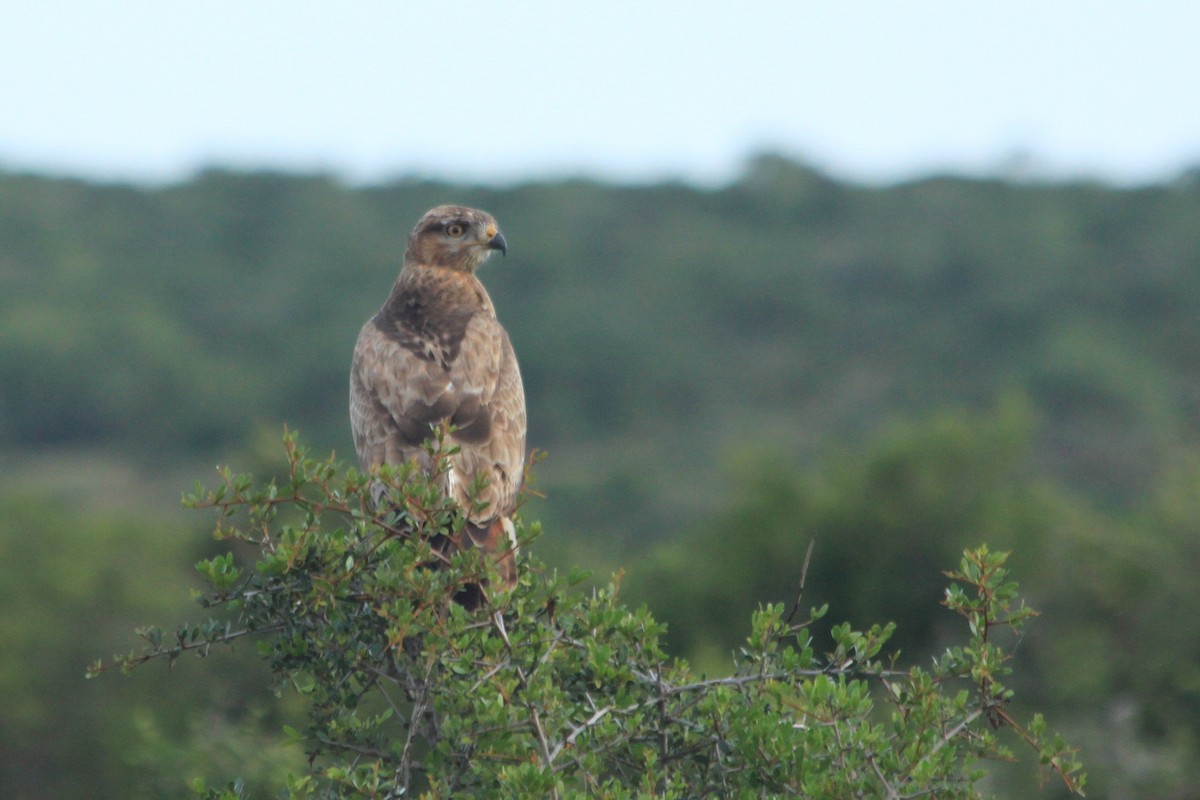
[0,0,1200,184]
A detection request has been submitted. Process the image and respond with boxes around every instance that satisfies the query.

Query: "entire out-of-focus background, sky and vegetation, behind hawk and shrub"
[0,0,1200,800]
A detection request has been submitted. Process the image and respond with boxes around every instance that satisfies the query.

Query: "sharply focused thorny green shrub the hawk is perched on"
[94,435,1084,800]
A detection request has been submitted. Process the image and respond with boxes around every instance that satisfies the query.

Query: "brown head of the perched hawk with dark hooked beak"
[404,205,509,272]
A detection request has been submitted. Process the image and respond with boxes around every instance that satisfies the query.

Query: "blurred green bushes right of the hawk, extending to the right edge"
[624,401,1200,798]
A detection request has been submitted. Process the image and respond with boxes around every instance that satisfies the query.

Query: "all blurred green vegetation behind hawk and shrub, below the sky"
[0,156,1200,798]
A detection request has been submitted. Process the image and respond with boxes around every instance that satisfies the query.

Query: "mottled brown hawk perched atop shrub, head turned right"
[350,205,526,607]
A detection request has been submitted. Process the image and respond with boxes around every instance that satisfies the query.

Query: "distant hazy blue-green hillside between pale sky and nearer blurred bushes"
[0,157,1200,536]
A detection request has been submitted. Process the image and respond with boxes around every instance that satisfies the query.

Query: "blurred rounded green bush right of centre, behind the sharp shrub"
[629,397,1055,657]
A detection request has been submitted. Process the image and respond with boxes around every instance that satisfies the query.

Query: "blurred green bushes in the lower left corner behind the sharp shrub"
[0,481,300,800]
